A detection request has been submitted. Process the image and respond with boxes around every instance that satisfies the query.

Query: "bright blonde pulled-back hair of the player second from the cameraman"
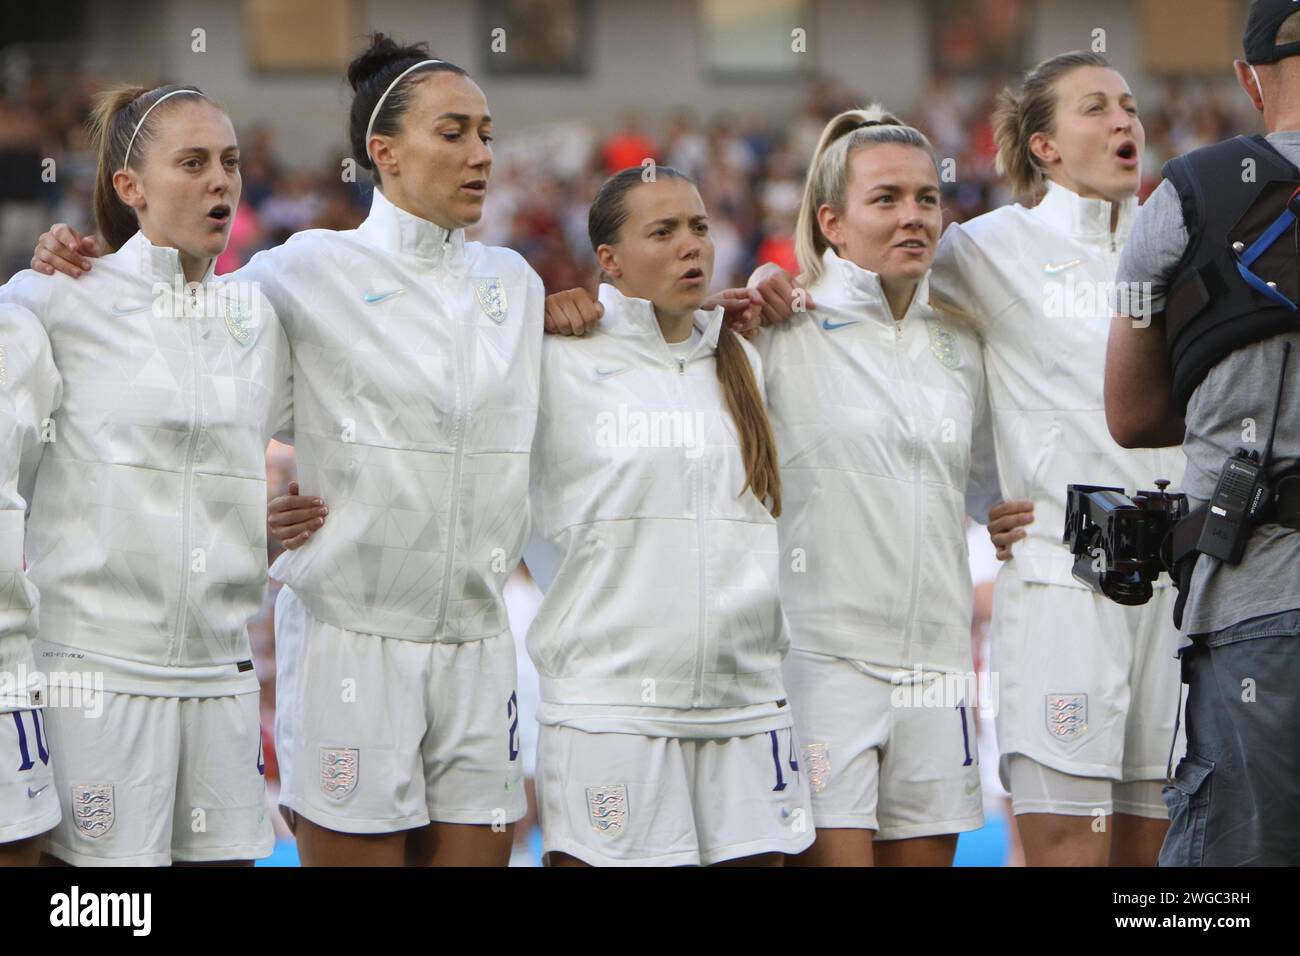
[794,103,939,285]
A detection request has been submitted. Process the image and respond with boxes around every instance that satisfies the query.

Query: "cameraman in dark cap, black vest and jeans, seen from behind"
[1105,0,1300,866]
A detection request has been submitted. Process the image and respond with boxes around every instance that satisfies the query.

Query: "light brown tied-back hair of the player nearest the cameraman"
[993,51,1110,196]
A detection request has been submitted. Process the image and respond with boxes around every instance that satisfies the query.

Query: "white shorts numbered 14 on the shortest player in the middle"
[537,726,815,866]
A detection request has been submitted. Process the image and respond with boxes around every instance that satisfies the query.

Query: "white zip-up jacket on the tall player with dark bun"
[244,190,545,643]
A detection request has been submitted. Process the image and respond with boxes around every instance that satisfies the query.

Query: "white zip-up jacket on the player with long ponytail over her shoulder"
[525,285,789,736]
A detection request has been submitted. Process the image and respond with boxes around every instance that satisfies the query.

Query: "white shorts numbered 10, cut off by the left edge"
[0,709,60,843]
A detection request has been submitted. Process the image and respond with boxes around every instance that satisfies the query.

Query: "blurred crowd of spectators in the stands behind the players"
[0,63,1258,863]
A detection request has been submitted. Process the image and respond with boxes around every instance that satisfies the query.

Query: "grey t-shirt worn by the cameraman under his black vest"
[1115,130,1300,635]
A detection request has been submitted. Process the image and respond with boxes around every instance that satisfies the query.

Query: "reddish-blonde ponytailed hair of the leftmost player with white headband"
[88,86,207,252]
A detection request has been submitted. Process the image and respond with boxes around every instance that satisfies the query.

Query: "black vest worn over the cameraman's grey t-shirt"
[1164,135,1300,414]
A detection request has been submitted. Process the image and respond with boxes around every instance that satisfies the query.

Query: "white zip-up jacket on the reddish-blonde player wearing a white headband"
[0,233,290,696]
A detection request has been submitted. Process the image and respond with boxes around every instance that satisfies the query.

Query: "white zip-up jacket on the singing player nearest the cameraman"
[931,183,1186,588]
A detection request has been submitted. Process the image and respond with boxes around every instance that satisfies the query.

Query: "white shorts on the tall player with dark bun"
[276,587,527,834]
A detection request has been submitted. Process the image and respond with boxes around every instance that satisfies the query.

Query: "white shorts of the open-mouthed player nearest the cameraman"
[989,558,1186,793]
